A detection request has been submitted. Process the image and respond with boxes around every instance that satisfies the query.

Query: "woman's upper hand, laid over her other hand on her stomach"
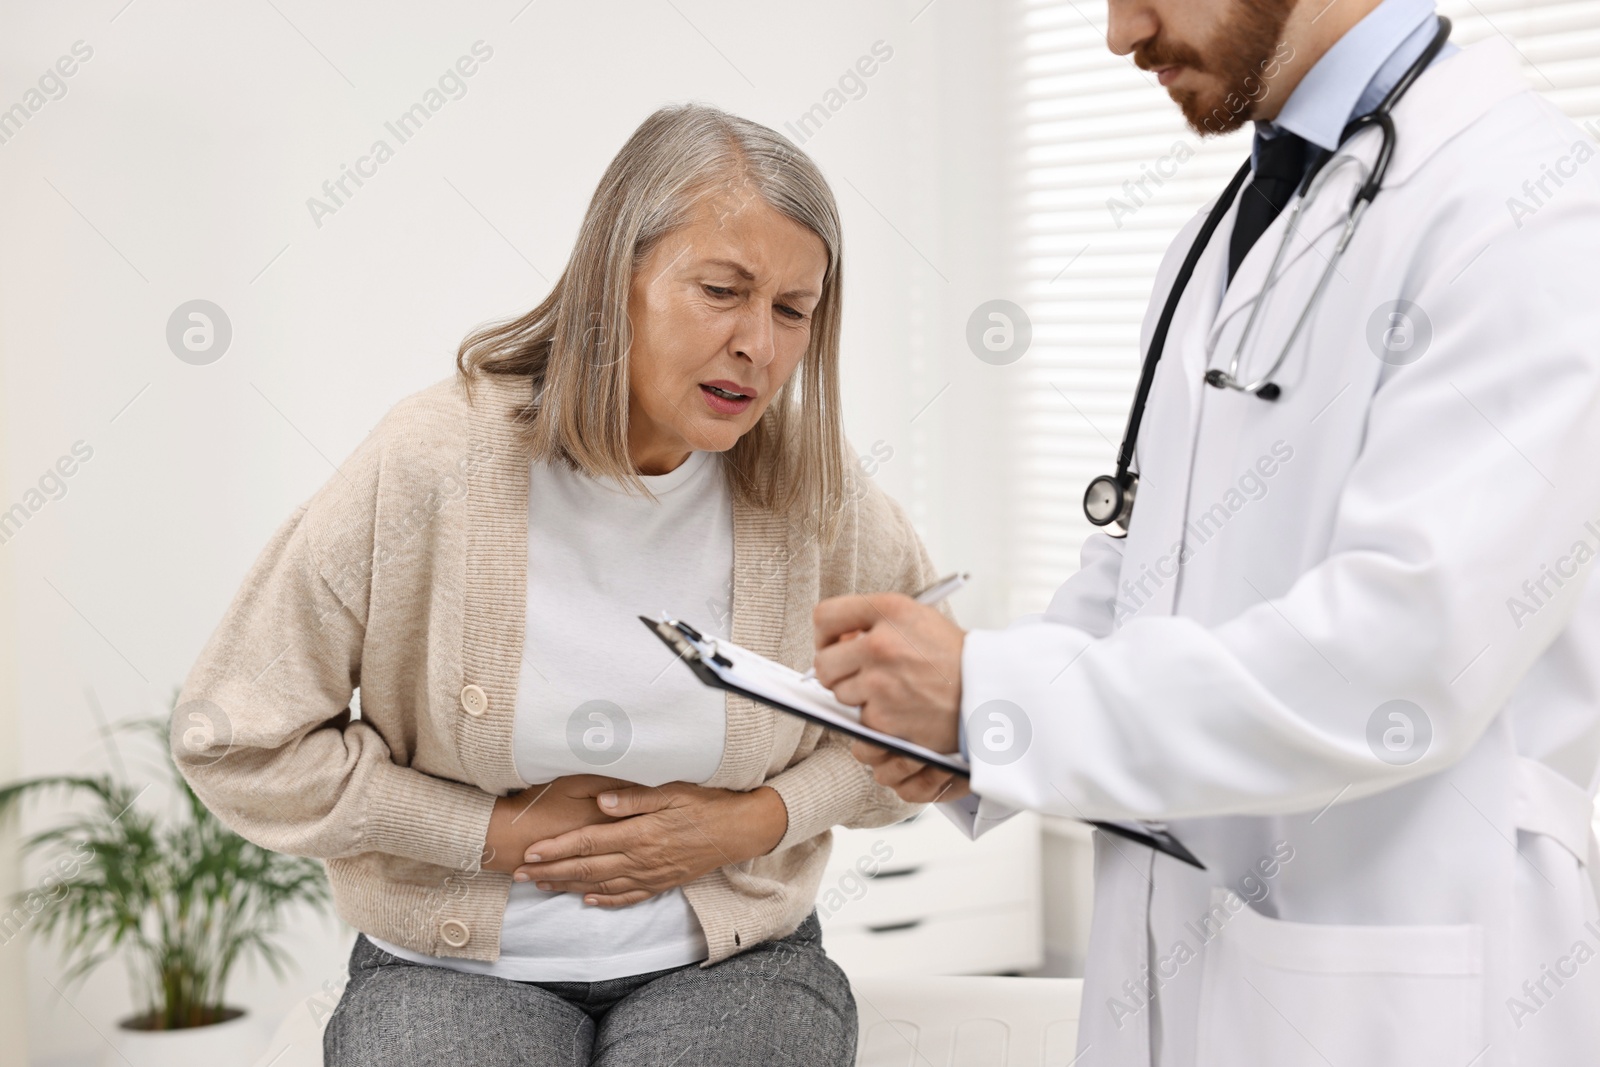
[514,782,789,907]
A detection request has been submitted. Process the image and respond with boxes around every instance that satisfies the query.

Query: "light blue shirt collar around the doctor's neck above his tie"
[1256,0,1437,152]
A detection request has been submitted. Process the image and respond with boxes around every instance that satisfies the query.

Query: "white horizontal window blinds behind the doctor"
[1008,0,1600,614]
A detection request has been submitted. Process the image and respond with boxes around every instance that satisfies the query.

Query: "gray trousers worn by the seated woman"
[323,912,856,1067]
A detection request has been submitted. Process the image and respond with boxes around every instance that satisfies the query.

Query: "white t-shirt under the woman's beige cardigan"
[371,453,733,982]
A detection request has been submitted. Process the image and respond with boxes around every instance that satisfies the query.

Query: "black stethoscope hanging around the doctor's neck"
[1083,16,1451,537]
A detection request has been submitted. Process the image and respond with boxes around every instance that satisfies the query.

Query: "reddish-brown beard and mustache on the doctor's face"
[1133,0,1296,138]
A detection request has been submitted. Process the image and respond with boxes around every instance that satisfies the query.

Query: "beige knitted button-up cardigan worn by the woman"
[171,376,933,963]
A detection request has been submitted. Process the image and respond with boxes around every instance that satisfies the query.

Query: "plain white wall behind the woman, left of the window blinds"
[0,0,1016,1064]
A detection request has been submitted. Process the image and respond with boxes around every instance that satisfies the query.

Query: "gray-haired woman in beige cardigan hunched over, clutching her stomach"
[171,106,933,1067]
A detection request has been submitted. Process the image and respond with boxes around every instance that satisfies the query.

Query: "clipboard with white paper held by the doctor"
[638,611,1205,870]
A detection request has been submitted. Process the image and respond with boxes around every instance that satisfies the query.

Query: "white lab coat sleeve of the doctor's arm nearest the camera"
[962,167,1600,819]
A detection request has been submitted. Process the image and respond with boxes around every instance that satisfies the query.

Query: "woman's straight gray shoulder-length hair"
[456,104,848,539]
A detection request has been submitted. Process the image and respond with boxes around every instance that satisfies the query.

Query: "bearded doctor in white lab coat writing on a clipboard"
[814,0,1600,1067]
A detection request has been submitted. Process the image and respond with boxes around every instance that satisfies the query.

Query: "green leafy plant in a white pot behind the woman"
[0,693,330,1067]
